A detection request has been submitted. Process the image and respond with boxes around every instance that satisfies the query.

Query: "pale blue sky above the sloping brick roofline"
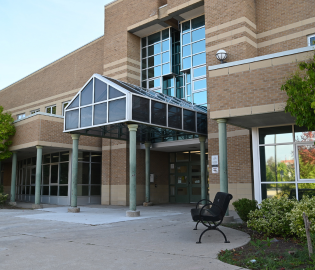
[0,0,112,89]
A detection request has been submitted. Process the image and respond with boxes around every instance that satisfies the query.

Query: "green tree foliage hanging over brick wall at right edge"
[281,54,315,130]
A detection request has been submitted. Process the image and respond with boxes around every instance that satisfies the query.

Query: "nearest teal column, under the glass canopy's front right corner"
[126,124,140,217]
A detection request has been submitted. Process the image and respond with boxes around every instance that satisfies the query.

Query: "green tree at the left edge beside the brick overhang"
[0,106,15,161]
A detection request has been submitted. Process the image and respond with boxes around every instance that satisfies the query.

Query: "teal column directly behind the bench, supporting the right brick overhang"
[217,119,229,216]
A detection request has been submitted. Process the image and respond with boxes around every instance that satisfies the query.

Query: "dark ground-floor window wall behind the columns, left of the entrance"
[17,151,102,204]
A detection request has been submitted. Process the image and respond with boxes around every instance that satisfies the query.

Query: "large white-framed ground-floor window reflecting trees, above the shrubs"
[256,125,315,200]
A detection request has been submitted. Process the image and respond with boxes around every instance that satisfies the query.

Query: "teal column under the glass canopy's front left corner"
[68,134,80,212]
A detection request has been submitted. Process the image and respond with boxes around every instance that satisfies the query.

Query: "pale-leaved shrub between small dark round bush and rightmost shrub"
[247,197,298,237]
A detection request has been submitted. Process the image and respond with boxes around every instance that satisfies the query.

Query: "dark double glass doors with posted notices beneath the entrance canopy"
[175,162,205,203]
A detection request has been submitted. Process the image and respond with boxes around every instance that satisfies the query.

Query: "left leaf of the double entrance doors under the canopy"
[175,162,190,203]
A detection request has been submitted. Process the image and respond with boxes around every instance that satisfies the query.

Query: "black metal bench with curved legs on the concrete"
[190,192,233,244]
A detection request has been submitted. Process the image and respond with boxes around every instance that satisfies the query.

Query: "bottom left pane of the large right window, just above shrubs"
[261,183,295,200]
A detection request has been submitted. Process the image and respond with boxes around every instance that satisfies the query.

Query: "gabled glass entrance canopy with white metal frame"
[64,74,207,141]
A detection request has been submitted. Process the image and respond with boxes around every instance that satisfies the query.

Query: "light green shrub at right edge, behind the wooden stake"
[288,196,315,239]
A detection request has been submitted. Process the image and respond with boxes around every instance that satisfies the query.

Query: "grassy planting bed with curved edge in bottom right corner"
[218,223,315,270]
